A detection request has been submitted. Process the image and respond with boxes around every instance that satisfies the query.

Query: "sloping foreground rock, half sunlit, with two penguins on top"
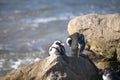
[0,56,100,80]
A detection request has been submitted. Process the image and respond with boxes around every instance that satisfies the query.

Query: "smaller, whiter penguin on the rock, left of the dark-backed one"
[49,40,66,55]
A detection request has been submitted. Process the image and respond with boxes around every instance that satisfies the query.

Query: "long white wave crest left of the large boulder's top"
[22,13,75,24]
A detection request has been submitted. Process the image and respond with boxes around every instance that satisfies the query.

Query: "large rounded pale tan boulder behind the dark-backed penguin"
[68,14,120,68]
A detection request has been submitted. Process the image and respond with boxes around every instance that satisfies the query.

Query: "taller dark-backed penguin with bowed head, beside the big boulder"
[66,32,86,56]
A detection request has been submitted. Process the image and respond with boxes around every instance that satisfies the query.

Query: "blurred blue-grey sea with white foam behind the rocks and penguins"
[0,0,120,76]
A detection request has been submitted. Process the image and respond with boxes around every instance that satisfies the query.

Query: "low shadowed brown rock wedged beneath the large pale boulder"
[83,50,120,72]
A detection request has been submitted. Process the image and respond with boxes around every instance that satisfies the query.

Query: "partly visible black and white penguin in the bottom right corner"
[102,68,120,80]
